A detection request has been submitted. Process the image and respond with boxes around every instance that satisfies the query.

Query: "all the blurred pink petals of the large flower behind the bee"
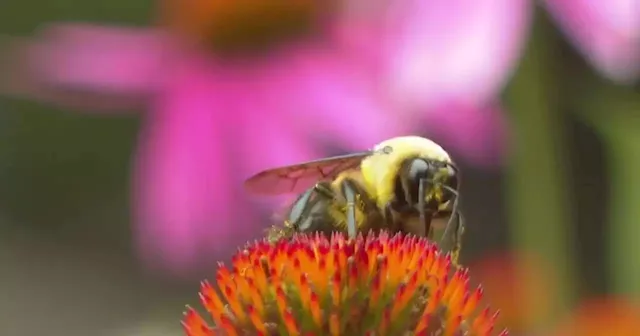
[2,0,529,270]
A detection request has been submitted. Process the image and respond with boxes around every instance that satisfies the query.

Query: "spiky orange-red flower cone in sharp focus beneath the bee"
[183,233,507,336]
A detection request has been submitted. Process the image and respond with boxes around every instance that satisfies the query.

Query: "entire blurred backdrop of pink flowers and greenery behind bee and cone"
[0,0,640,336]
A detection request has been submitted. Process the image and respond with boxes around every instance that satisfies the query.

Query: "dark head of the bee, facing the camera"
[394,157,458,213]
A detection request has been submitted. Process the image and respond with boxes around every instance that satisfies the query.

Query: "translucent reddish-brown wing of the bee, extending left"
[244,151,375,195]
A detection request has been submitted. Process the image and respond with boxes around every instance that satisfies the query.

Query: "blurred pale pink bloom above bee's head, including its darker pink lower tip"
[344,0,533,166]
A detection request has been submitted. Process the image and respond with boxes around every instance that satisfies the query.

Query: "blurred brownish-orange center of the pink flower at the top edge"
[164,0,331,54]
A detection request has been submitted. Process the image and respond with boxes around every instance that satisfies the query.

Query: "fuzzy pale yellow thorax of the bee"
[360,136,451,208]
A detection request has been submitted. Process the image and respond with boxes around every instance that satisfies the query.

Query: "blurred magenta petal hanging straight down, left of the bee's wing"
[134,56,231,271]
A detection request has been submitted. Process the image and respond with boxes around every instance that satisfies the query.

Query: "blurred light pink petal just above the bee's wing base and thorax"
[277,50,404,150]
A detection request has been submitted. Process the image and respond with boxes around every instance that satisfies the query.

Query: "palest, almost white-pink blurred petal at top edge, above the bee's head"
[383,0,532,106]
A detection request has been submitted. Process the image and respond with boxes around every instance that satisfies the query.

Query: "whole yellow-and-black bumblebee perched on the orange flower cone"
[245,136,464,263]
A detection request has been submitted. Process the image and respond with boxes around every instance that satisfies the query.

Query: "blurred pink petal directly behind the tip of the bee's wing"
[216,68,323,211]
